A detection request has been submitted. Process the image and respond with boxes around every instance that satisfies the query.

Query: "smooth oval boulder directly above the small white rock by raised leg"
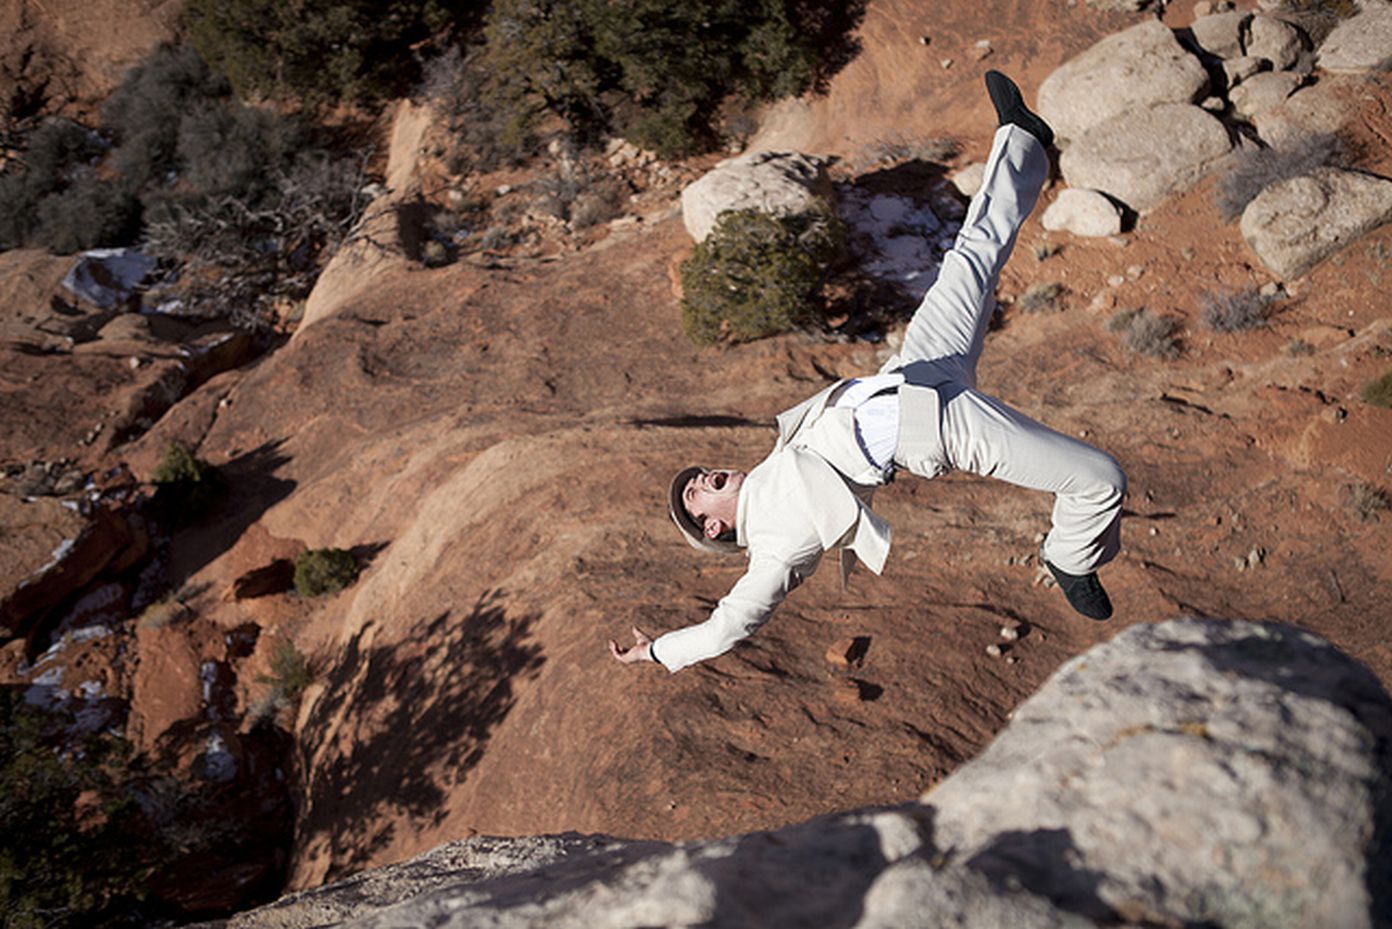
[1059,103,1232,210]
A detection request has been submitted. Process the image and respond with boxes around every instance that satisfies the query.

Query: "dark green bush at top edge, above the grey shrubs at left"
[184,0,467,104]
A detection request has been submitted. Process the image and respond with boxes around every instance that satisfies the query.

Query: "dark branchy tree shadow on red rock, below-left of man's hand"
[299,591,546,880]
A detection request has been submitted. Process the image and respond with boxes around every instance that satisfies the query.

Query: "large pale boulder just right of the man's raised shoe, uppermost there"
[1038,19,1208,139]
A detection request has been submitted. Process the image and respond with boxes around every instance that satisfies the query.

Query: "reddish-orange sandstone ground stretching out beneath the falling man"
[0,0,1392,919]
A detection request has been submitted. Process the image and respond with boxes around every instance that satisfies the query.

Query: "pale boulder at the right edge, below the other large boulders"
[1240,167,1392,280]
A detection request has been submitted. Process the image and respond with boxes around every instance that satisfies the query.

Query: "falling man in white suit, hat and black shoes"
[608,71,1126,671]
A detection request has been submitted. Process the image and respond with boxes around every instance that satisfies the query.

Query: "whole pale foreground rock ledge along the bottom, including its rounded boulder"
[211,620,1392,929]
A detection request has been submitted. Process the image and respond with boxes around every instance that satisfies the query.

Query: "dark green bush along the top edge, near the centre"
[484,0,862,157]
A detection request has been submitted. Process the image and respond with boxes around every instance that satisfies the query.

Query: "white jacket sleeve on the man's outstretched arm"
[653,554,820,673]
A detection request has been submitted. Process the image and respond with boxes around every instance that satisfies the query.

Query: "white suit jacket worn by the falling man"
[653,382,918,671]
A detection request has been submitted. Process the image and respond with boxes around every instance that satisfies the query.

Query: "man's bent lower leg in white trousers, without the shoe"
[942,390,1126,575]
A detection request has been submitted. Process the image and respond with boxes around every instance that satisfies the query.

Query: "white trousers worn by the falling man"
[887,125,1126,574]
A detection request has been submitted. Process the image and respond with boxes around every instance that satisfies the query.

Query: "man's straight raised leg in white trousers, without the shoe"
[895,125,1048,384]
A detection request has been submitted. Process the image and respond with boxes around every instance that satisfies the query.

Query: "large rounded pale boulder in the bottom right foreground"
[924,621,1392,929]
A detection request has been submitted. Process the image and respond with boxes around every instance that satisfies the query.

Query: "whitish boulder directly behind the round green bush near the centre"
[682,152,831,242]
